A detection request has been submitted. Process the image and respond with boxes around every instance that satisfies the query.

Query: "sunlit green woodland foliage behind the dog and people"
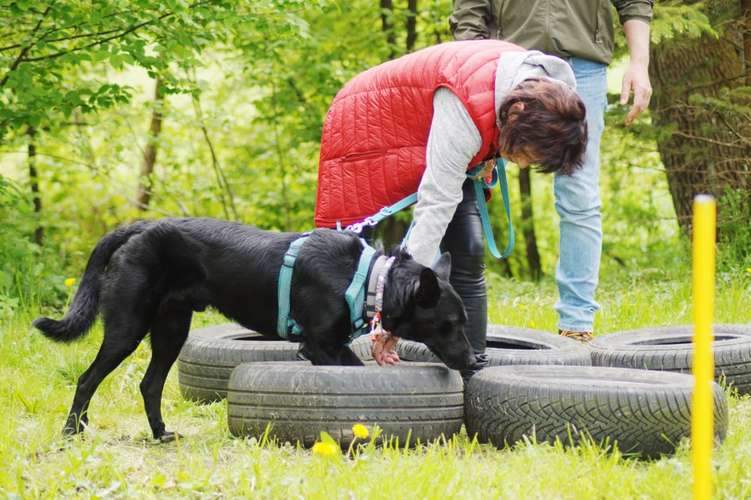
[0,0,748,300]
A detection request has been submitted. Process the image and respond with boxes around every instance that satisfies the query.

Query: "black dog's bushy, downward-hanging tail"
[33,221,151,342]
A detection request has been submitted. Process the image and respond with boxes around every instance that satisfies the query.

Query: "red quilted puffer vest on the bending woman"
[315,40,524,227]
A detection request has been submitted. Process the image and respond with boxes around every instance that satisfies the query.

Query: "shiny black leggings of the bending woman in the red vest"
[441,179,488,354]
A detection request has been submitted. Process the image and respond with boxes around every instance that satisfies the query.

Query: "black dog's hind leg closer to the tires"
[141,301,193,442]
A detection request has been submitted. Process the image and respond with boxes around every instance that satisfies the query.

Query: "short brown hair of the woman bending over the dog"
[498,78,587,175]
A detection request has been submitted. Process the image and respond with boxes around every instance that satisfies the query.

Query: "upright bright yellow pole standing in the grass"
[691,195,717,500]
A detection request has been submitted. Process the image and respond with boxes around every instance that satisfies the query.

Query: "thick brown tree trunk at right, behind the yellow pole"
[650,0,751,235]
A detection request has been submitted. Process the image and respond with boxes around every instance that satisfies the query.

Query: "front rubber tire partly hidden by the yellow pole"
[465,365,728,458]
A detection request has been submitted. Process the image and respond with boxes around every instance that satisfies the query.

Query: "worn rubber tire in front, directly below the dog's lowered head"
[227,363,464,449]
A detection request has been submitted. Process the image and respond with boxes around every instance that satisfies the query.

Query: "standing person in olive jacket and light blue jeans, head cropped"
[450,0,653,341]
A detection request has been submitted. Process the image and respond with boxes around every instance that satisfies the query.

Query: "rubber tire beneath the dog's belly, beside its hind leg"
[177,323,299,403]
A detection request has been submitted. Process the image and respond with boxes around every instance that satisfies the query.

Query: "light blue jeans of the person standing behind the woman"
[554,57,607,331]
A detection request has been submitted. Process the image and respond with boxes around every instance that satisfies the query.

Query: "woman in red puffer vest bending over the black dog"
[315,40,587,377]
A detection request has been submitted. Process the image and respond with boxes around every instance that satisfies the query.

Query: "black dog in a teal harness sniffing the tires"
[34,219,478,441]
